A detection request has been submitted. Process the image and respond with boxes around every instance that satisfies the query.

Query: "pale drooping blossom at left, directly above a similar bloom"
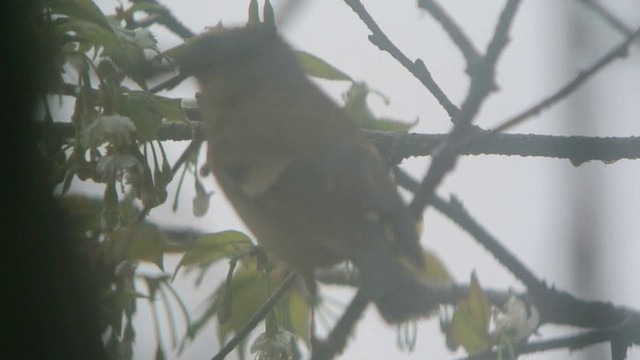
[82,114,136,148]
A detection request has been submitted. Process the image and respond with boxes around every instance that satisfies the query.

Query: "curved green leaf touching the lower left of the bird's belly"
[174,230,253,278]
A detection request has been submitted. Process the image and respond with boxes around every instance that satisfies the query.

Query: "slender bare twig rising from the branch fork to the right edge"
[488,28,640,137]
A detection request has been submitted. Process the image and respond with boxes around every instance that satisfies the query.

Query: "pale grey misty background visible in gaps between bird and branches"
[56,0,640,359]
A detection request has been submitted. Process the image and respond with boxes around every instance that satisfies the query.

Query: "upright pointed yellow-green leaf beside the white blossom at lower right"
[447,273,491,355]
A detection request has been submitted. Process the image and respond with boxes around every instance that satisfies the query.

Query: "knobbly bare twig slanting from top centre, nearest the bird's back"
[344,0,458,118]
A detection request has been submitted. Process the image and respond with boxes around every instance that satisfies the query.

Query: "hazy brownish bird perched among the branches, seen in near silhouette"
[177,26,434,323]
